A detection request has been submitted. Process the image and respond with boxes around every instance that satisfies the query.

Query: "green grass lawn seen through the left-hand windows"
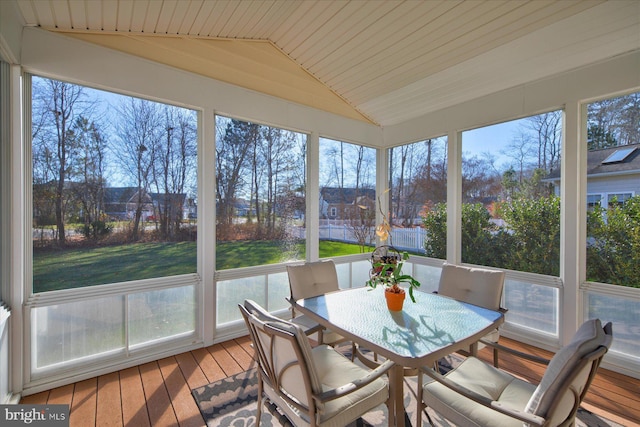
[33,240,360,293]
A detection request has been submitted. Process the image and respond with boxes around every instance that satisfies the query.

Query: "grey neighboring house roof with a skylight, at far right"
[545,144,640,181]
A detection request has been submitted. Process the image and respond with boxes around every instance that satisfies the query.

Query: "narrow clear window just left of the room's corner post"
[320,138,376,257]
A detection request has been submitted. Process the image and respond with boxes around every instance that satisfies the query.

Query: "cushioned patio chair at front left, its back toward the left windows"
[239,300,393,427]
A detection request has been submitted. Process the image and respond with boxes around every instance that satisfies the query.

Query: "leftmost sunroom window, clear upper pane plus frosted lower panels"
[27,76,199,373]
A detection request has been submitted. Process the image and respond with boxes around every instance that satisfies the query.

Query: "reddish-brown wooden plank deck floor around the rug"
[21,337,640,427]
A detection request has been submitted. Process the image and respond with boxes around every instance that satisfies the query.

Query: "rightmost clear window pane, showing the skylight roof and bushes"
[587,92,640,290]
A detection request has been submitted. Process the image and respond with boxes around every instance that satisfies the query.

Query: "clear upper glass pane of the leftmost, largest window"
[32,77,197,293]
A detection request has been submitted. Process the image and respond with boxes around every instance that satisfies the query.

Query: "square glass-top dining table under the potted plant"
[294,287,504,427]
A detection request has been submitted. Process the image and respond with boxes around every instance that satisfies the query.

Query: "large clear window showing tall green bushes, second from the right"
[461,111,562,276]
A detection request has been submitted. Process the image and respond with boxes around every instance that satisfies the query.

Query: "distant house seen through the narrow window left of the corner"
[320,187,376,220]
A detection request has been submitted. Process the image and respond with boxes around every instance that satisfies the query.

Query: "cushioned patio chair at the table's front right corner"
[418,319,613,427]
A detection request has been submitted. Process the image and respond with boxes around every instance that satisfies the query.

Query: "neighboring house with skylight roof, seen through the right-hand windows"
[546,144,640,208]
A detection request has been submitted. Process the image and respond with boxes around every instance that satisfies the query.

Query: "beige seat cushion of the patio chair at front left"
[312,345,389,426]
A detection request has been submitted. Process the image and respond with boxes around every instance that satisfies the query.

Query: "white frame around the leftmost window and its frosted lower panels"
[21,73,204,393]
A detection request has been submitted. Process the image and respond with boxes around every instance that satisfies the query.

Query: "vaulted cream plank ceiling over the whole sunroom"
[12,0,640,126]
